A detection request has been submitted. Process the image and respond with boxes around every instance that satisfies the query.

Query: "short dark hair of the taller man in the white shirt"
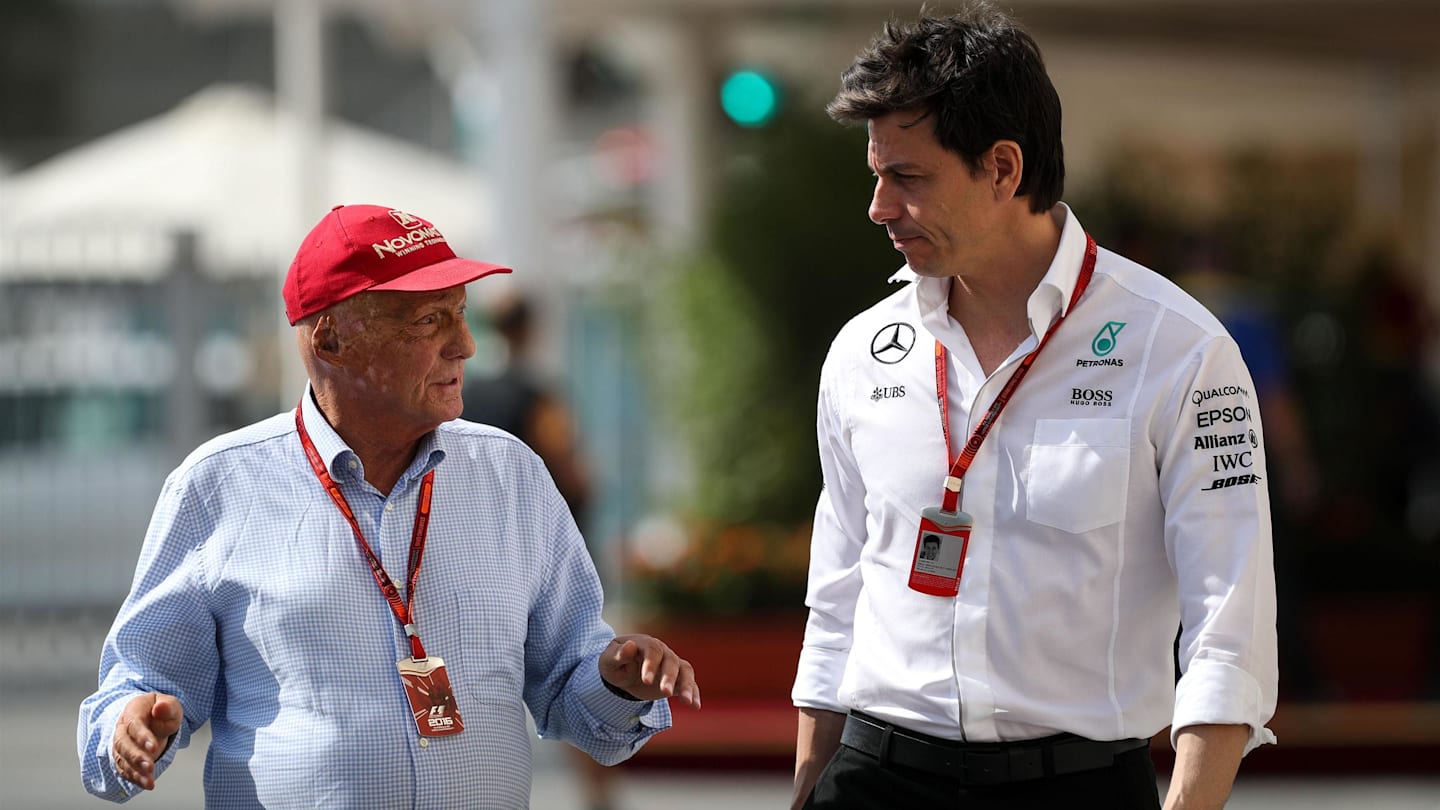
[825,1,1066,213]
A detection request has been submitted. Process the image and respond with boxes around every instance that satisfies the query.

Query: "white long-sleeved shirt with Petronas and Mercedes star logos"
[792,205,1277,751]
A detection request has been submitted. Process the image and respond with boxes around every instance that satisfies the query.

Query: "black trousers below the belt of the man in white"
[805,745,1161,810]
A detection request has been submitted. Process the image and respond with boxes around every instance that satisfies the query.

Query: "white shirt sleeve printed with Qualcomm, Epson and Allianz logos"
[1155,337,1279,752]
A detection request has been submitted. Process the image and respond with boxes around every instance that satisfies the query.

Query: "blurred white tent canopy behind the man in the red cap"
[0,85,491,280]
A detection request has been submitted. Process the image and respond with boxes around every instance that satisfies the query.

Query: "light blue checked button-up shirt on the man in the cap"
[76,391,670,810]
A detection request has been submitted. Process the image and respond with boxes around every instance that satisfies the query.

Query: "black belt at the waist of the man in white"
[840,712,1149,785]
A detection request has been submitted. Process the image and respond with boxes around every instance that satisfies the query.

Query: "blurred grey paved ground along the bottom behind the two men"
[0,683,1440,810]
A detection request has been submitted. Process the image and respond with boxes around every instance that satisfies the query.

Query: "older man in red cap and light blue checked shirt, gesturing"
[78,206,700,809]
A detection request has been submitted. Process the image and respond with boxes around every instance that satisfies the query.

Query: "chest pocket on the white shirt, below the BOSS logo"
[1025,419,1130,533]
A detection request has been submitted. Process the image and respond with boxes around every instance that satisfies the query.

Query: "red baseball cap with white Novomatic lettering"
[285,205,510,326]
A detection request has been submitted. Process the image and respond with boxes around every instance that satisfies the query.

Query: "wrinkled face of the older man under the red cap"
[329,285,475,437]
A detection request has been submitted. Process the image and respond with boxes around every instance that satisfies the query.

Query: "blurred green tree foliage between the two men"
[658,104,904,526]
